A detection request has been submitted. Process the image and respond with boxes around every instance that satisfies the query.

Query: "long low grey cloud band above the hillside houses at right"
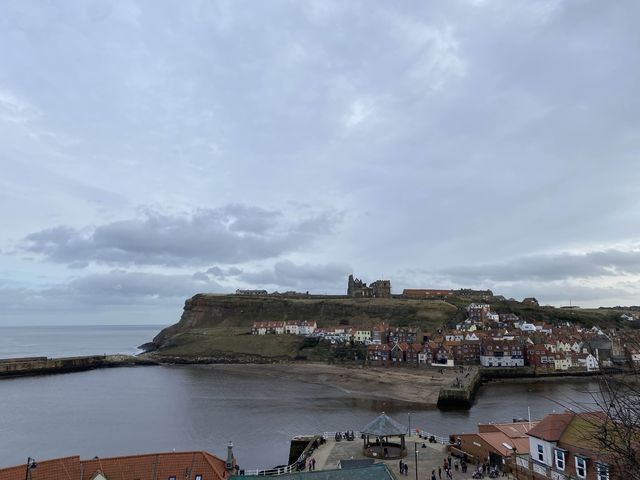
[437,249,640,284]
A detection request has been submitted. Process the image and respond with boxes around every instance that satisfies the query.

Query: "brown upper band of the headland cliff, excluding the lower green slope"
[149,294,457,348]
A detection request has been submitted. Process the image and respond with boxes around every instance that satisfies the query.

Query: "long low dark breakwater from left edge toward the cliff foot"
[0,355,158,378]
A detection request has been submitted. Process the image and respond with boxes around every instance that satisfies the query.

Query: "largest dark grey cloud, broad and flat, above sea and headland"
[23,205,337,265]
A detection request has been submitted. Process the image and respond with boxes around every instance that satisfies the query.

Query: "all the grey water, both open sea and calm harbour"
[0,325,597,469]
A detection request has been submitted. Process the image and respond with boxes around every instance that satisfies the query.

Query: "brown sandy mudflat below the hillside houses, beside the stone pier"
[205,363,456,407]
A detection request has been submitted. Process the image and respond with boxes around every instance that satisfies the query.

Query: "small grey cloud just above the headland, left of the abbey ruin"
[239,260,351,291]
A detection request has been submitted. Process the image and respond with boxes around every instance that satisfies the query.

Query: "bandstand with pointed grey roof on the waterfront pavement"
[360,412,408,459]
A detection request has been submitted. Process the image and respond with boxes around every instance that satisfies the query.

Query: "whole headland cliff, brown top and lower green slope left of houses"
[143,294,459,357]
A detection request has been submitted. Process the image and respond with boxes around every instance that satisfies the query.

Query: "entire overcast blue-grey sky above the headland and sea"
[0,0,640,325]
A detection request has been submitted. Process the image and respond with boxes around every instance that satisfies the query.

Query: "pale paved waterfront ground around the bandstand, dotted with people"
[304,436,513,480]
